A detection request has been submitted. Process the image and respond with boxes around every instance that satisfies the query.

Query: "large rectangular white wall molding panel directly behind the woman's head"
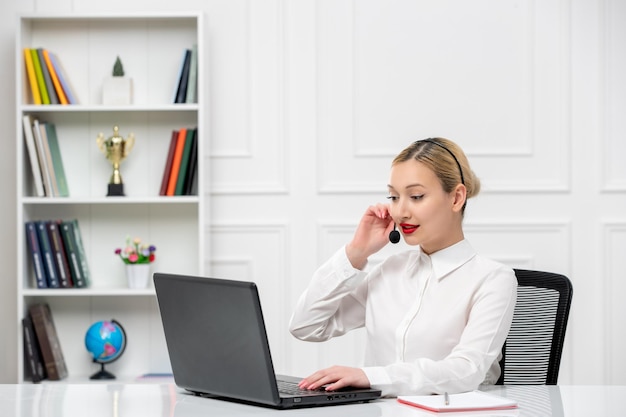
[316,0,571,194]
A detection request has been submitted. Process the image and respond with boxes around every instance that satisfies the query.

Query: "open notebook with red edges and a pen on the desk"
[398,391,517,412]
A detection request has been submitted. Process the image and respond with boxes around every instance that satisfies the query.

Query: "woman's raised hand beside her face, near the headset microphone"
[346,203,394,269]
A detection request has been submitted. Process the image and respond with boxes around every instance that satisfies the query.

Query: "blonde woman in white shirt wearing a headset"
[290,138,517,396]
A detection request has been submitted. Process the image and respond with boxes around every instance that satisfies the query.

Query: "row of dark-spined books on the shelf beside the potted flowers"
[24,219,90,288]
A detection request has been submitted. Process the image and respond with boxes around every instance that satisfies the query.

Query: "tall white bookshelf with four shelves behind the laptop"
[15,13,208,382]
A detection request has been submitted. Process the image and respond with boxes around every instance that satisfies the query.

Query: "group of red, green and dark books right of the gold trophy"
[159,128,198,196]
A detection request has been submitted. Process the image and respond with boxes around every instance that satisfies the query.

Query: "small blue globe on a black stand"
[85,320,126,379]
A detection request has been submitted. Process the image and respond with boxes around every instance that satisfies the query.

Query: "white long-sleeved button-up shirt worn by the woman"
[290,240,517,396]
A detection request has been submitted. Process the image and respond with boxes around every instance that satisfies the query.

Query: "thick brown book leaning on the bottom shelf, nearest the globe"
[28,303,67,381]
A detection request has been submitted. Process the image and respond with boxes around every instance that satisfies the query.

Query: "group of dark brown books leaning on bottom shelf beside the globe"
[22,303,67,382]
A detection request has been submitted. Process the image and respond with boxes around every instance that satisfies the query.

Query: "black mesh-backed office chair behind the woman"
[496,269,572,385]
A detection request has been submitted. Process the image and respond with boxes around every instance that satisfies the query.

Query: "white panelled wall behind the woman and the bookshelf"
[0,0,626,384]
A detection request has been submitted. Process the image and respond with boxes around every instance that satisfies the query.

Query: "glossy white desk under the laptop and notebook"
[0,383,626,417]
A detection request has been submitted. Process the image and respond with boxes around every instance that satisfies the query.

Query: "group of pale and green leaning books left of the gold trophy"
[22,114,70,197]
